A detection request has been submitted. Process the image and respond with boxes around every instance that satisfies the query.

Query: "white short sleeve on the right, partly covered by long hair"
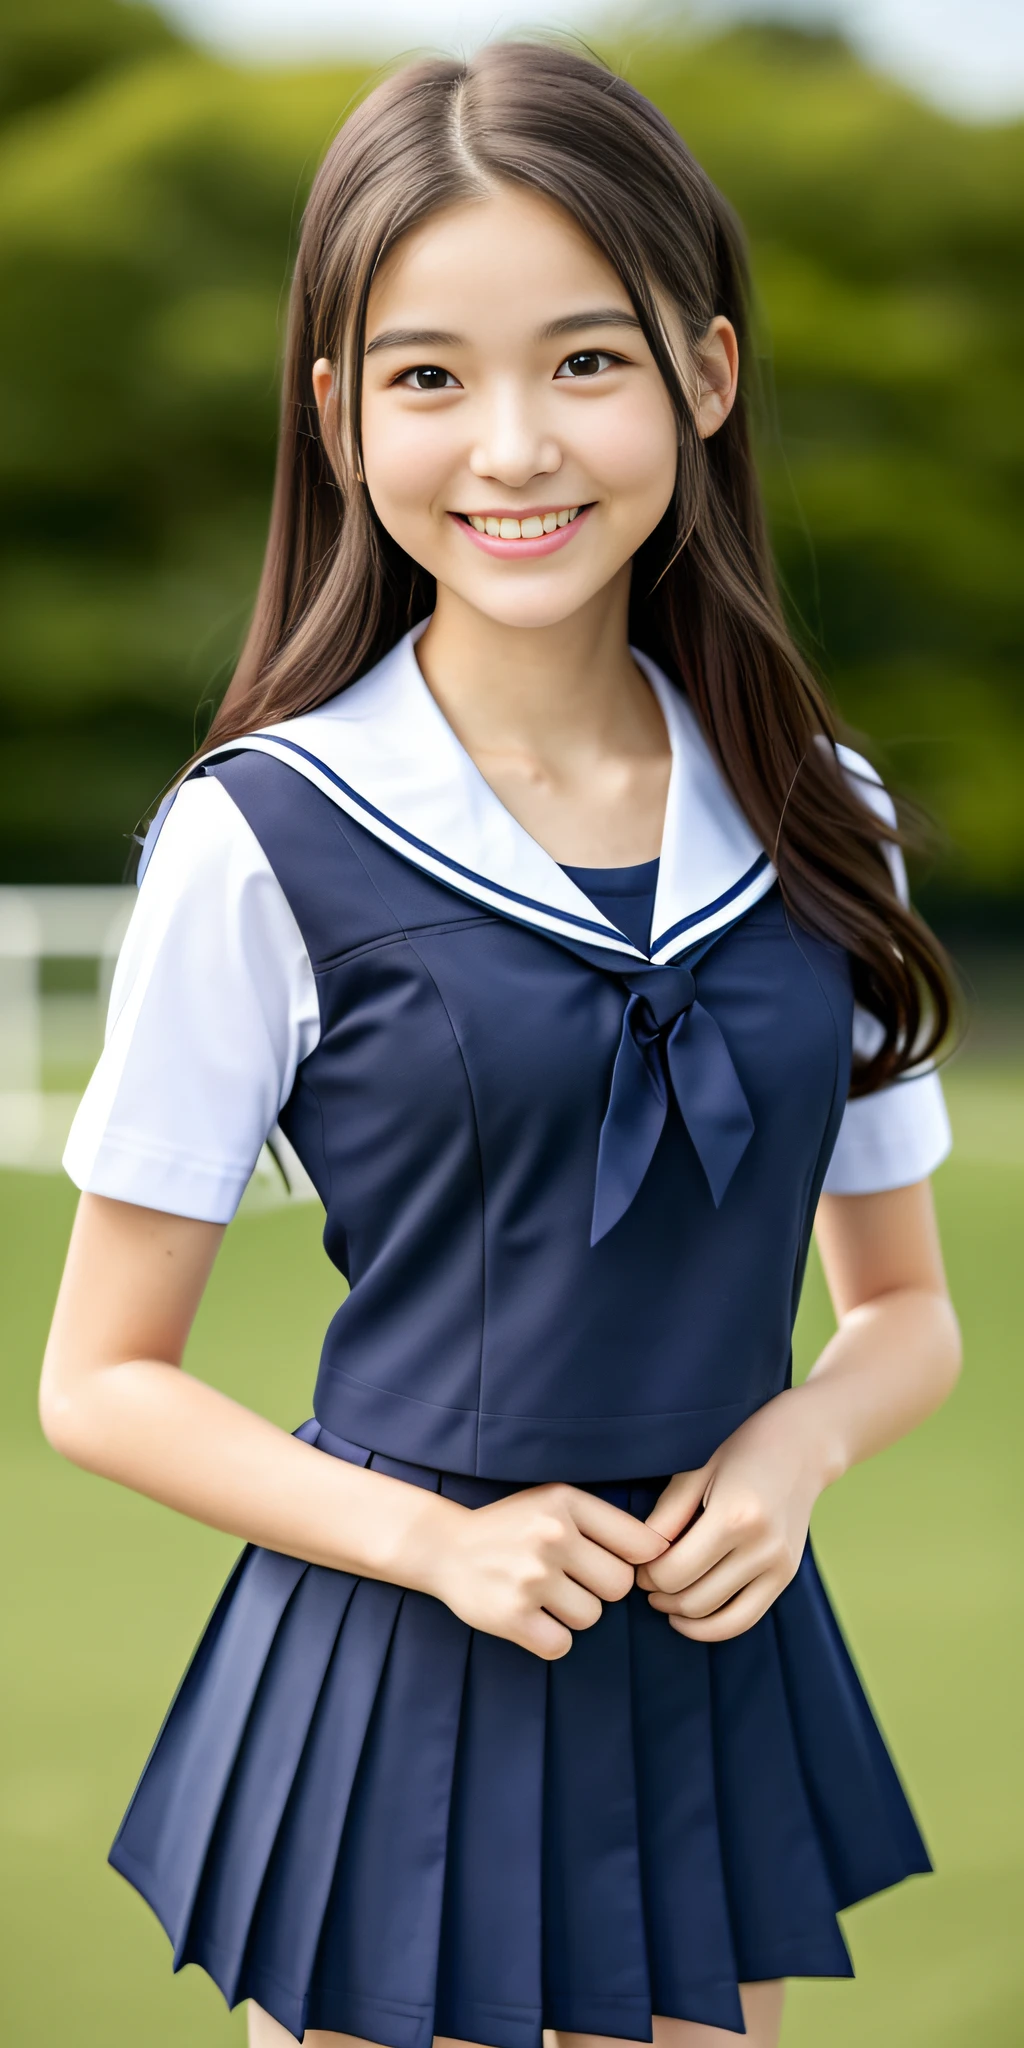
[821,748,952,1194]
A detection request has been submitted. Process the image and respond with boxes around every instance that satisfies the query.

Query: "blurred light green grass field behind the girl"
[0,1067,1024,2048]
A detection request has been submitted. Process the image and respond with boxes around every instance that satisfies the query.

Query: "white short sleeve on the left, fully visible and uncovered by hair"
[63,776,319,1223]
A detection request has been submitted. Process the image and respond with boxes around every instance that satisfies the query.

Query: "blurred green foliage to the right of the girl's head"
[631,29,1024,915]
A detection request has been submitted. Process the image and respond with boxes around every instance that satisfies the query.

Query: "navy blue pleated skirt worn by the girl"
[111,1423,930,2048]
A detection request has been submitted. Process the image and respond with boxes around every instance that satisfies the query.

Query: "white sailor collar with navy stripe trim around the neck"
[207,621,774,967]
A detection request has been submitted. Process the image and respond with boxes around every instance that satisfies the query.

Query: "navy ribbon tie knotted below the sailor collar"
[590,967,754,1245]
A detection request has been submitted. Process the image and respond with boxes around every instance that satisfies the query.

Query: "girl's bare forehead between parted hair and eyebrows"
[367,184,631,340]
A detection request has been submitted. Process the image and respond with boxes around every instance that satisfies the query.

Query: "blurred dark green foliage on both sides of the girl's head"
[0,0,1024,922]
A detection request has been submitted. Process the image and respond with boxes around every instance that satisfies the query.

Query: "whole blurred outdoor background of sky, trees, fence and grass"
[0,0,1024,2048]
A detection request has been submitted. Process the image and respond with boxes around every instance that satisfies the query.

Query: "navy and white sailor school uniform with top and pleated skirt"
[66,627,948,2048]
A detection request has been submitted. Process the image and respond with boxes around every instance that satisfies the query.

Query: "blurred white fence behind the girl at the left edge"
[0,887,315,1208]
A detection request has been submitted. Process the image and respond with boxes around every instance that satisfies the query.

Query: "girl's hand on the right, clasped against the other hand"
[637,1389,829,1642]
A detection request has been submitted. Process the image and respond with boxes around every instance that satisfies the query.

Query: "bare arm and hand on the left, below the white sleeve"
[39,1194,664,1657]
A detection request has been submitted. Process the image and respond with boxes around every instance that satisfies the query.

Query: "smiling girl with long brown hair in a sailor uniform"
[41,43,958,2048]
